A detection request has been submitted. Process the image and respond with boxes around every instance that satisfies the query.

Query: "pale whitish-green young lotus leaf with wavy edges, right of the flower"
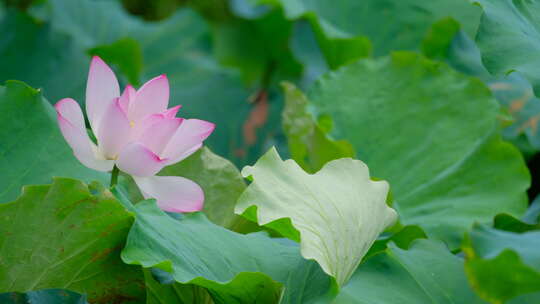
[236,149,397,286]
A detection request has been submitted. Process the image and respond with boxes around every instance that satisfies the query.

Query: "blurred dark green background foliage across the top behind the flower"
[0,0,540,198]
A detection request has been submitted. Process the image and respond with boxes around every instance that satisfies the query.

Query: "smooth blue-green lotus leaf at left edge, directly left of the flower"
[0,81,107,203]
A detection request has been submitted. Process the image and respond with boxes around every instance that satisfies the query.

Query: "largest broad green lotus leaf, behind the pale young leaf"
[308,52,530,249]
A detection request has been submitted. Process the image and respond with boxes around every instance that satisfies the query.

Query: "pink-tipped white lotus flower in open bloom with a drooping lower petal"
[55,56,215,212]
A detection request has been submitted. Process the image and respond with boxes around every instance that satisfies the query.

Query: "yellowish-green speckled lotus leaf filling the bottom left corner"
[0,178,145,303]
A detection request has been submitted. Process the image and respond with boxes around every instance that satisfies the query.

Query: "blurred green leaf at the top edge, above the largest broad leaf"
[252,0,480,56]
